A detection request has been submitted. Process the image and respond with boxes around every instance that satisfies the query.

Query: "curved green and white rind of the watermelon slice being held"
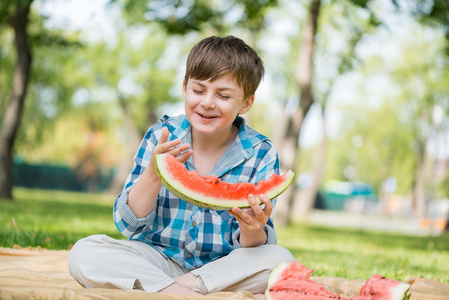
[155,154,295,210]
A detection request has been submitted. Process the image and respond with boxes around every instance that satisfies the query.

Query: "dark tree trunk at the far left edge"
[0,1,32,200]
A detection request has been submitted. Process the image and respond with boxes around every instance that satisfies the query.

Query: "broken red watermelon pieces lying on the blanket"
[265,261,410,300]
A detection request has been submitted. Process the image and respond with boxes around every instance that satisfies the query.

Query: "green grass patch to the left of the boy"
[0,188,121,250]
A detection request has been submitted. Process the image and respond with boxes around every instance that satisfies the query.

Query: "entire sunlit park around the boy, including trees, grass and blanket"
[0,0,449,300]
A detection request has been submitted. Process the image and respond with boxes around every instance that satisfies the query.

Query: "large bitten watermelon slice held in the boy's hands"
[155,154,295,210]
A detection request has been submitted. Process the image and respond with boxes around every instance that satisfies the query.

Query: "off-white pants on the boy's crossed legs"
[68,235,294,294]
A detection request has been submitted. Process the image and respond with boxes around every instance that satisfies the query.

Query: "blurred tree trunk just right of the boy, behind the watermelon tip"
[274,0,321,226]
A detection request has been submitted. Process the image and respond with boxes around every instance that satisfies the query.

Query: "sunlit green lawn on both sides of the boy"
[0,188,449,282]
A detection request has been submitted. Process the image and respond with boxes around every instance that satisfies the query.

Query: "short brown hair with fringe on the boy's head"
[184,36,264,99]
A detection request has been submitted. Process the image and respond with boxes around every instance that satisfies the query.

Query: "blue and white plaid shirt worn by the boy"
[114,115,279,270]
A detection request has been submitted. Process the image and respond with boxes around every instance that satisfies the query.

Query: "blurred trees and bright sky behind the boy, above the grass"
[0,0,449,234]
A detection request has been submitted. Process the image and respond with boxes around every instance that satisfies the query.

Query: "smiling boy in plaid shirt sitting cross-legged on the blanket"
[68,36,293,297]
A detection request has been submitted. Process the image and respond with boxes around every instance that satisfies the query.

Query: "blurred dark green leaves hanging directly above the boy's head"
[113,0,278,35]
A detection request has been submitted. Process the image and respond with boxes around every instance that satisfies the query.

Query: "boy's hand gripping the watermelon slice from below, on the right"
[229,194,273,237]
